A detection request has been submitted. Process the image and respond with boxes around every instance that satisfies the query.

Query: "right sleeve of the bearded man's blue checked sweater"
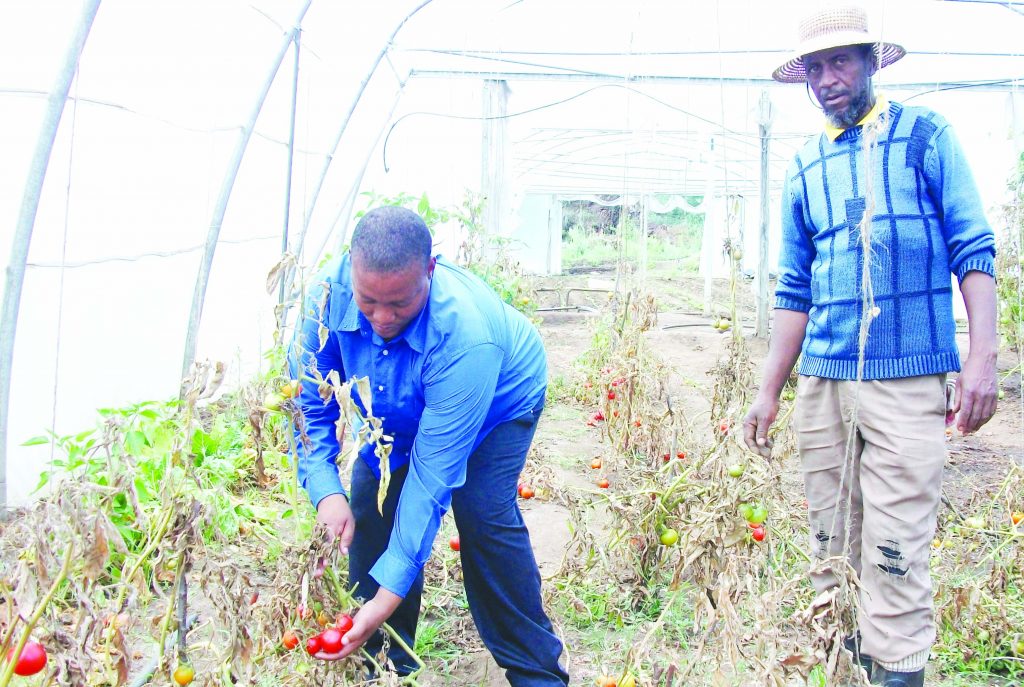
[925,125,995,282]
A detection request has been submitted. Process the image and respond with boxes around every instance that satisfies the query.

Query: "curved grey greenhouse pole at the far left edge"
[0,0,100,518]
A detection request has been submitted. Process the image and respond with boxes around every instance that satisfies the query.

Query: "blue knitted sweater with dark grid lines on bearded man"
[775,102,995,379]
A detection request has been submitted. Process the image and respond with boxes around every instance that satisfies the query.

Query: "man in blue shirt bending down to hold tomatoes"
[290,207,568,687]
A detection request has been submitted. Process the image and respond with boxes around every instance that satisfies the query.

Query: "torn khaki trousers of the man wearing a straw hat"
[796,375,946,672]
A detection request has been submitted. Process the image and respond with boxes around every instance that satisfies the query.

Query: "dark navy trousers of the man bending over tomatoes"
[349,409,568,687]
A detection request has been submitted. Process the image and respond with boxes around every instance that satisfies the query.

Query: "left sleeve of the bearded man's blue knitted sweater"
[775,165,814,312]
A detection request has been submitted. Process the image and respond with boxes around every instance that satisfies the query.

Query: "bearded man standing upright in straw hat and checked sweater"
[743,7,997,687]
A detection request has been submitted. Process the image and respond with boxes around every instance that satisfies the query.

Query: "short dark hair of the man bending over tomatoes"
[348,205,433,272]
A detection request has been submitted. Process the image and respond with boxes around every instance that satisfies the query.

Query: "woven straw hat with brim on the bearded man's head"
[771,5,906,84]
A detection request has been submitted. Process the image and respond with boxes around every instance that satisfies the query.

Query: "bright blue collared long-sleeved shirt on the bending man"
[289,253,547,597]
